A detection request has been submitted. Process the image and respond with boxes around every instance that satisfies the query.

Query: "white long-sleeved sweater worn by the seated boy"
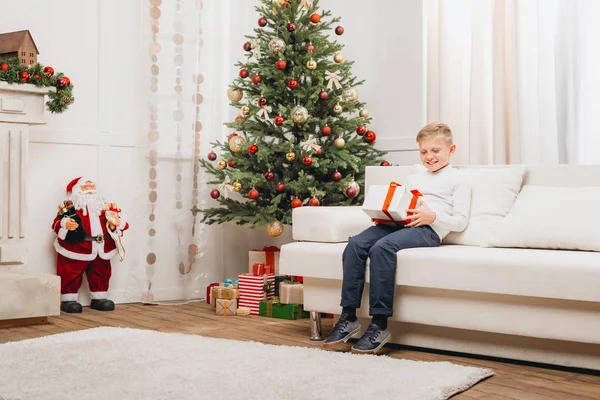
[405,165,471,240]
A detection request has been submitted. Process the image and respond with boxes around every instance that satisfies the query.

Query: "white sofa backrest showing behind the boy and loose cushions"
[365,164,600,189]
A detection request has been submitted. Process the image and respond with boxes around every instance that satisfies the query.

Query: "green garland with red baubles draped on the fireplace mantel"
[0,58,75,114]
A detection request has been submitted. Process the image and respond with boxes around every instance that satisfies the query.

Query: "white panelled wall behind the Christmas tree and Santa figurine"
[0,0,425,303]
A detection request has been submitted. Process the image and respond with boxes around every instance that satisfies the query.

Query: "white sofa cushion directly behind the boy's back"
[443,166,525,246]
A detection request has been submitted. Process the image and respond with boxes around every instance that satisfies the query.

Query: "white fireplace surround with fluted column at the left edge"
[0,82,60,326]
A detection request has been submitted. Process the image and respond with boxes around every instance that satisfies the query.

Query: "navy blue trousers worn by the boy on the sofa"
[341,224,440,317]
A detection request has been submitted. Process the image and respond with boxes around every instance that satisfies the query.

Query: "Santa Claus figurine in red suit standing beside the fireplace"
[52,177,129,313]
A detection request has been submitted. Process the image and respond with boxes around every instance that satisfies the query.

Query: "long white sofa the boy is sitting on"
[280,165,600,370]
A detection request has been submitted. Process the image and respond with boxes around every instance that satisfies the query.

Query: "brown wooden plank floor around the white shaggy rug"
[0,303,600,400]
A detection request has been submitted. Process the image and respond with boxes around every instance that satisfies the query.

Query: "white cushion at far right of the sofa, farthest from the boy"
[486,185,600,250]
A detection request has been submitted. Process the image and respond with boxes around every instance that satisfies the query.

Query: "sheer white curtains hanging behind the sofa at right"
[425,0,600,164]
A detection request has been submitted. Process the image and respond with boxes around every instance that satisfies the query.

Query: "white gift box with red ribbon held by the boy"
[362,182,422,223]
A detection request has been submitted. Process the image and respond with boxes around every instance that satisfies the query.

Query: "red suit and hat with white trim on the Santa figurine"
[52,178,129,302]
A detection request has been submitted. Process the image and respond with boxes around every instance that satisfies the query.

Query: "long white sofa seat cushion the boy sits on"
[280,243,600,301]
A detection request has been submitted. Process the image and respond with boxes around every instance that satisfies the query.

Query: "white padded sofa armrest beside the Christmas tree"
[292,206,373,243]
